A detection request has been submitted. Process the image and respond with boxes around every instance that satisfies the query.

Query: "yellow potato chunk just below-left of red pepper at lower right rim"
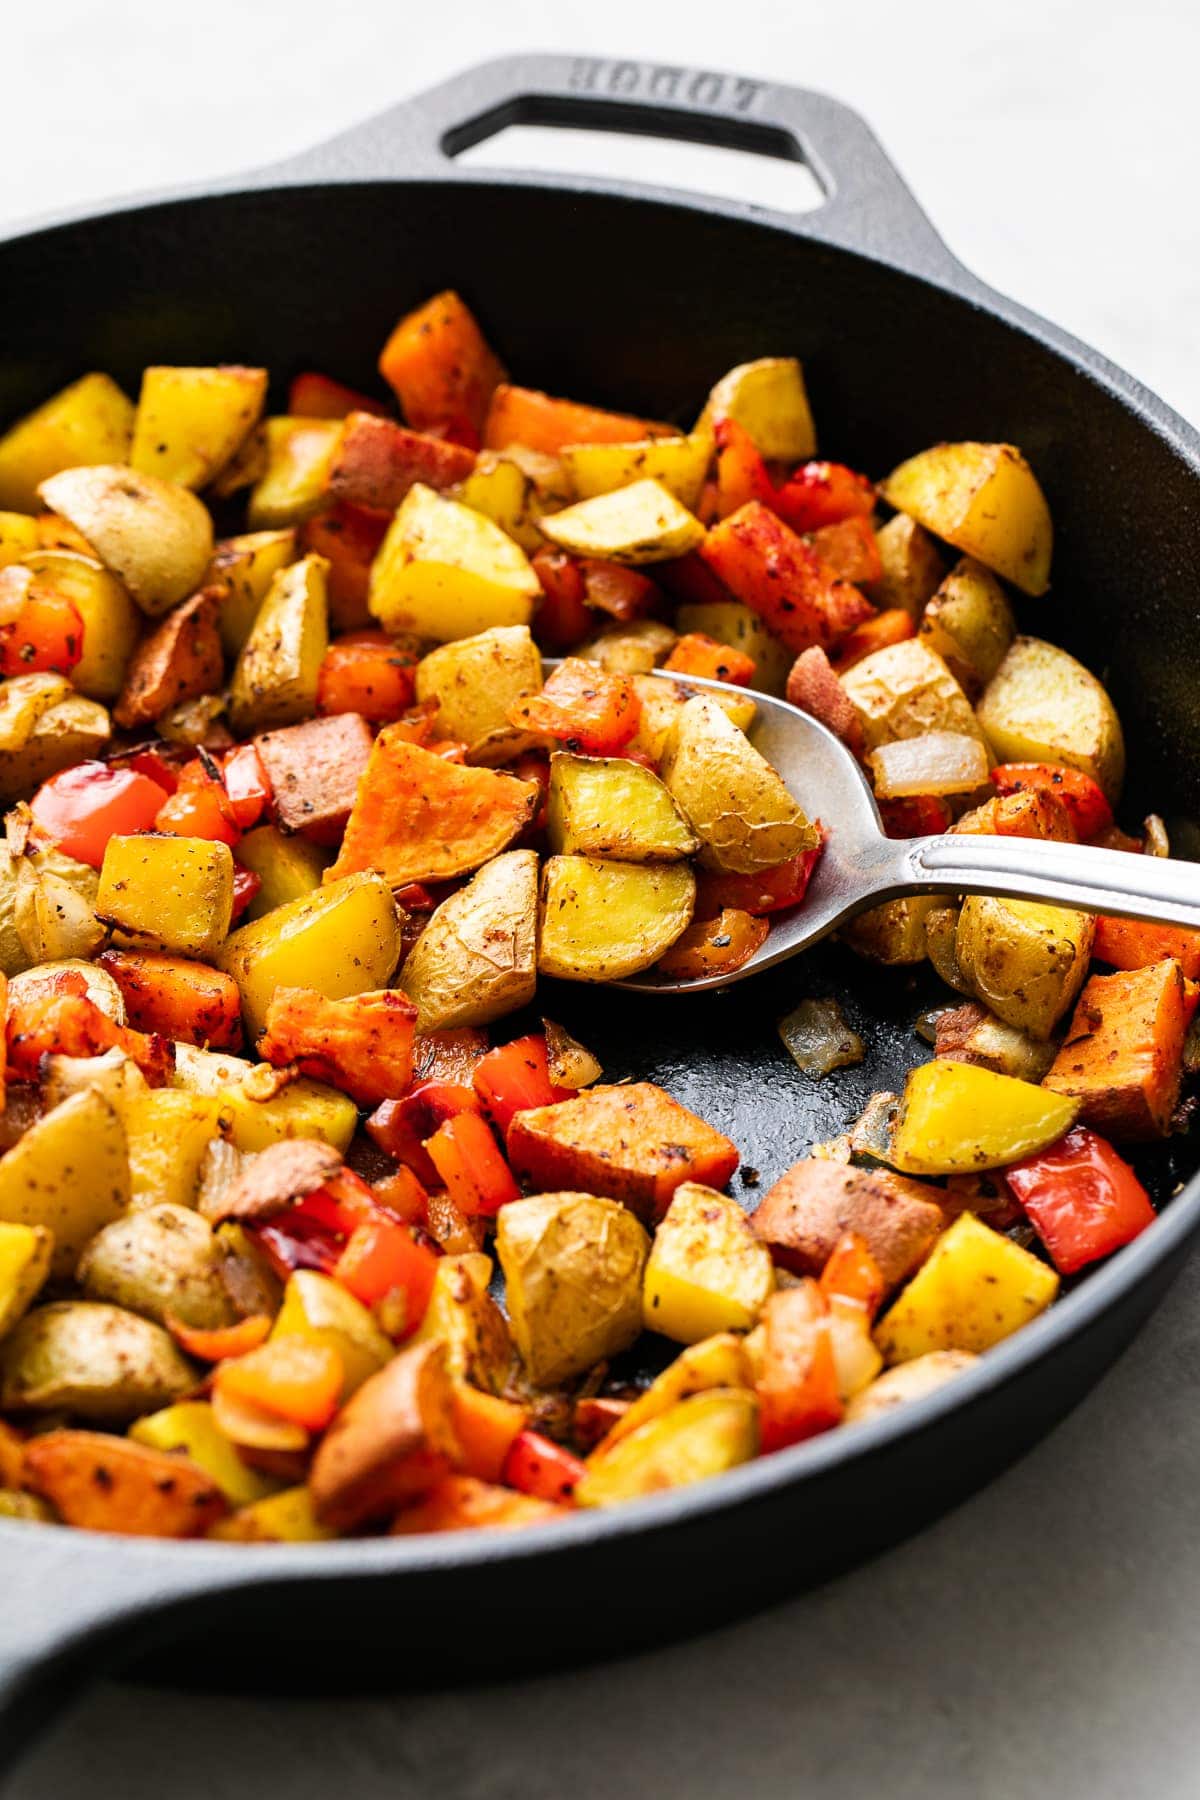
[874,1209,1058,1363]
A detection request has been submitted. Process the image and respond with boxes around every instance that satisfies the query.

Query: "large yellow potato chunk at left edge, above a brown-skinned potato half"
[0,1091,130,1278]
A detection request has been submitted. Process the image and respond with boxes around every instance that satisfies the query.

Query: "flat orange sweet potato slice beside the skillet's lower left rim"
[25,1431,228,1537]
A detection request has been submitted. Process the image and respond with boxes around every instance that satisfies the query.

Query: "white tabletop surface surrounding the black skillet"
[0,0,1200,1800]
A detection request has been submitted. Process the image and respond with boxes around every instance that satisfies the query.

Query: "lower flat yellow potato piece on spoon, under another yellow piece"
[538,857,696,981]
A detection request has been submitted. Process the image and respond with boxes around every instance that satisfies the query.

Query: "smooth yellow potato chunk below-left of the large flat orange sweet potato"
[218,875,401,1042]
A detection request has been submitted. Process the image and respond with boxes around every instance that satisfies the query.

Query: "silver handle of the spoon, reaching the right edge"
[896,832,1200,931]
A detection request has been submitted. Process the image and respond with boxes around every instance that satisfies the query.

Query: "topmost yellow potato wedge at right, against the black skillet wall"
[880,443,1054,594]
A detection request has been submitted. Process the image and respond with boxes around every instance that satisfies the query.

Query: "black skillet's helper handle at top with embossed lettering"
[261,54,959,277]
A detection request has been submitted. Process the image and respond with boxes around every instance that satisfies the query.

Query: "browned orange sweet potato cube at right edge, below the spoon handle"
[1042,958,1200,1139]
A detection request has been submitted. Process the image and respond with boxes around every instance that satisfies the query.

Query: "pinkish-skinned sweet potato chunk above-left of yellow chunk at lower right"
[752,1157,946,1287]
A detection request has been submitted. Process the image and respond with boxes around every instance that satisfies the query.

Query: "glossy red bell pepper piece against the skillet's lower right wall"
[1004,1125,1155,1274]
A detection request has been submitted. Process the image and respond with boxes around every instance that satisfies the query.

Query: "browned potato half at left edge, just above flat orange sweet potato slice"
[0,1300,196,1426]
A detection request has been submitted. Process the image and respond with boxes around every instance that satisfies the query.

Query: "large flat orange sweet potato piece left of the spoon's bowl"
[326,725,540,887]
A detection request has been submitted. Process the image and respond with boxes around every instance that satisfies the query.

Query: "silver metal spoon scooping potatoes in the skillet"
[613,675,1200,994]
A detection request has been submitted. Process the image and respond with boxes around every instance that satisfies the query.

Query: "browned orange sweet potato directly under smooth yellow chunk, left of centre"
[257,988,417,1107]
